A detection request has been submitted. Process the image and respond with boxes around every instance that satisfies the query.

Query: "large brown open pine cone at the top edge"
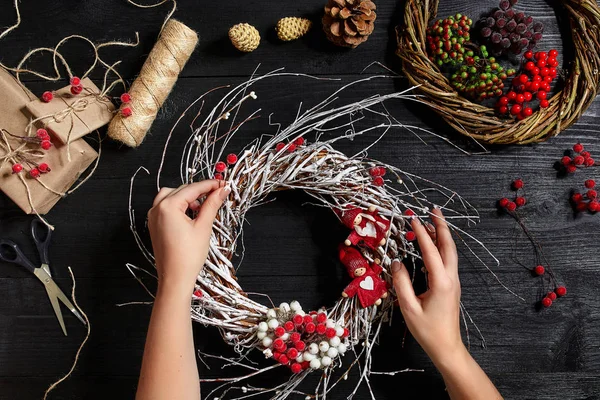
[323,0,377,48]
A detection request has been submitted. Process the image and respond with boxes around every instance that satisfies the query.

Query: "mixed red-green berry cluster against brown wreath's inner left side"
[427,14,473,67]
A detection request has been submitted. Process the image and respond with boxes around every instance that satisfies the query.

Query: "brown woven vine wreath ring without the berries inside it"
[396,0,600,144]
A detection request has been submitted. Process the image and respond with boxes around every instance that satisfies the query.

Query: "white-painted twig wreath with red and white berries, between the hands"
[130,72,497,399]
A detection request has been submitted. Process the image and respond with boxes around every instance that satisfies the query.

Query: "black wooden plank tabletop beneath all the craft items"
[0,0,600,399]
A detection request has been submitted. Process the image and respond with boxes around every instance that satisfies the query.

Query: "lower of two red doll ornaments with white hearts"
[339,246,388,307]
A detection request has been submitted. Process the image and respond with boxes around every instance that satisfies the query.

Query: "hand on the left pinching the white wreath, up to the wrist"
[148,180,231,294]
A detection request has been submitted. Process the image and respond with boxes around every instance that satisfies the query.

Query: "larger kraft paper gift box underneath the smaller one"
[0,68,98,214]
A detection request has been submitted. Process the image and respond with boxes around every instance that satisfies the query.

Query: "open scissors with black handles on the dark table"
[0,219,87,336]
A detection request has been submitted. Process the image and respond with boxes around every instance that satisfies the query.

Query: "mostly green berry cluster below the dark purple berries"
[450,46,516,101]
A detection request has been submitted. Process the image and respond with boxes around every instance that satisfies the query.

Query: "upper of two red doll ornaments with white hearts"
[338,208,390,250]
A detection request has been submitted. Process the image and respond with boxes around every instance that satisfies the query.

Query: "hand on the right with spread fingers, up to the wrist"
[392,209,466,367]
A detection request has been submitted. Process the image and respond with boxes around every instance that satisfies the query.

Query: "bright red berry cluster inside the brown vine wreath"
[496,50,558,120]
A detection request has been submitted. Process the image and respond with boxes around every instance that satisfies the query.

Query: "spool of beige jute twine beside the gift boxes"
[108,19,198,147]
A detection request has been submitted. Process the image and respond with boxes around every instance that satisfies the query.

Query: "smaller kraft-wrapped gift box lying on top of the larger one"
[27,78,115,143]
